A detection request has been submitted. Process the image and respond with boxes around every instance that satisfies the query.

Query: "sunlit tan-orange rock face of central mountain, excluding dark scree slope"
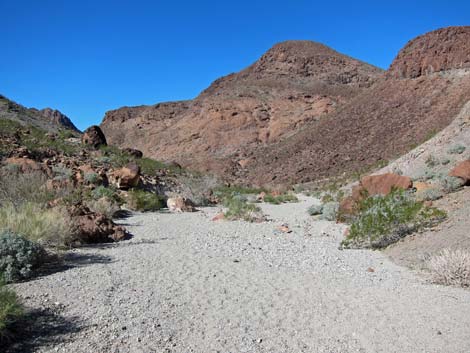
[101,41,382,170]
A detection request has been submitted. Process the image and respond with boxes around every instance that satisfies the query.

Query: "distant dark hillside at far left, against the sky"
[0,95,80,132]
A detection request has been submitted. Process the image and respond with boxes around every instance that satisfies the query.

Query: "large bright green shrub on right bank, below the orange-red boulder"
[341,190,446,248]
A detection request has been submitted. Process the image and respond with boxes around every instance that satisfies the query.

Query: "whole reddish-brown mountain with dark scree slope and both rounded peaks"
[102,27,470,184]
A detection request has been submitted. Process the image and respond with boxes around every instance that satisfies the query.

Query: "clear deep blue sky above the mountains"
[0,0,470,129]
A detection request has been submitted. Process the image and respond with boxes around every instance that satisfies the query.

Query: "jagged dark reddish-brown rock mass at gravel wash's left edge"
[67,204,127,244]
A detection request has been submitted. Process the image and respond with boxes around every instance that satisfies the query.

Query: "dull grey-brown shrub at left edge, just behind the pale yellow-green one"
[0,170,58,206]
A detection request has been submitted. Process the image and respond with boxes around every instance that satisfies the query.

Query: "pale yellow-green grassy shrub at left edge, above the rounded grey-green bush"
[0,202,70,246]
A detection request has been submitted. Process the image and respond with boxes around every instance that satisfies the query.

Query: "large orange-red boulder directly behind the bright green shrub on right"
[356,173,413,196]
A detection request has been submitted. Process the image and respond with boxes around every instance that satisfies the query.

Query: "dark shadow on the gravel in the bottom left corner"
[0,309,84,353]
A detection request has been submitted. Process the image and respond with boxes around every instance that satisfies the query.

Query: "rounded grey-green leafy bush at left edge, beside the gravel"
[0,231,46,282]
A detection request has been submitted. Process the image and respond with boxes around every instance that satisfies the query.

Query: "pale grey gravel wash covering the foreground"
[9,199,470,353]
